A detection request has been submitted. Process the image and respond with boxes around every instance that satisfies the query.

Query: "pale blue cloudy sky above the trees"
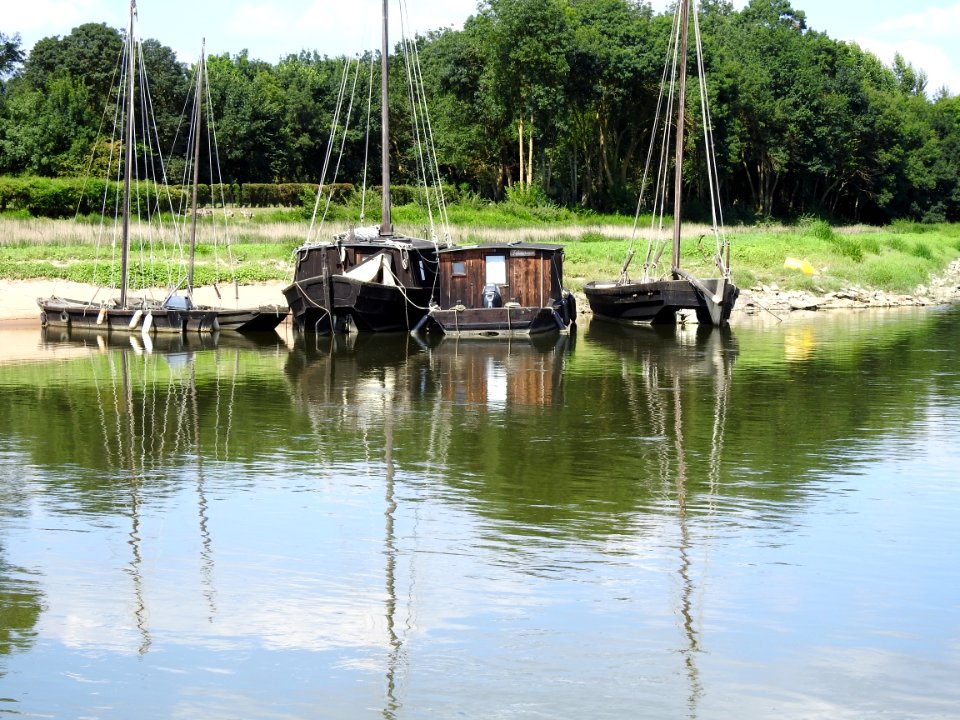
[0,0,960,95]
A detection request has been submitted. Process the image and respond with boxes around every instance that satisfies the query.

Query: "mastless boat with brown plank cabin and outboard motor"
[416,242,577,337]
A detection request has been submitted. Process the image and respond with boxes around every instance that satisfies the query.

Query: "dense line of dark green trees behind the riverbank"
[0,0,960,222]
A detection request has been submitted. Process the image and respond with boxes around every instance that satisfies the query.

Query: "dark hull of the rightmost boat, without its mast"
[583,278,740,327]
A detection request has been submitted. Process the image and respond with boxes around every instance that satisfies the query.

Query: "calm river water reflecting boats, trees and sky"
[0,309,960,719]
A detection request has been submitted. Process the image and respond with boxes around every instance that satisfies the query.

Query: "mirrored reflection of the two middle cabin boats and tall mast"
[285,333,573,717]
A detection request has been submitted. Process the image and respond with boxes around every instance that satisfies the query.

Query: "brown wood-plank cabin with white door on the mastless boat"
[437,243,563,308]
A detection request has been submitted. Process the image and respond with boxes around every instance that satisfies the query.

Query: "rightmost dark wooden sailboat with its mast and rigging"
[583,0,740,327]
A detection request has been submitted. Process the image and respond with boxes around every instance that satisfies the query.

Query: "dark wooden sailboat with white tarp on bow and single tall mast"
[283,0,438,333]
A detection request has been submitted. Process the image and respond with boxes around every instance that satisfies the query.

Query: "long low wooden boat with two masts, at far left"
[37,0,288,334]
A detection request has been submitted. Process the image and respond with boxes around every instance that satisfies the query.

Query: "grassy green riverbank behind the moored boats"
[0,206,960,293]
